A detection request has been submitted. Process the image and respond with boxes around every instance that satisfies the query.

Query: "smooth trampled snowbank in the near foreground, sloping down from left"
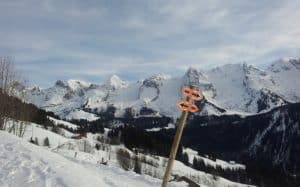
[0,131,186,187]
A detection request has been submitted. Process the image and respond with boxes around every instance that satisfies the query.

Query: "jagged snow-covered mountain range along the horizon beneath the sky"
[26,59,300,121]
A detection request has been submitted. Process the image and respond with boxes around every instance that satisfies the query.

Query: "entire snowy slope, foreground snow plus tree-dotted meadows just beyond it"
[0,118,253,187]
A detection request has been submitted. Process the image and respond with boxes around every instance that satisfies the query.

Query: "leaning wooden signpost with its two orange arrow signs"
[161,87,203,187]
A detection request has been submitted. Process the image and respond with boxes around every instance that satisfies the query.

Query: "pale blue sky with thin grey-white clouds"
[0,0,300,86]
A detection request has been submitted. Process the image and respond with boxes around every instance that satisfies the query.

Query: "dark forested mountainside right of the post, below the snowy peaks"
[168,103,300,187]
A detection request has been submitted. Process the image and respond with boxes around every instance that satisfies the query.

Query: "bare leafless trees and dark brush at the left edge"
[0,57,55,130]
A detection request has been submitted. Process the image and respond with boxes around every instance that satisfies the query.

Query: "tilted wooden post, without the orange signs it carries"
[161,97,189,187]
